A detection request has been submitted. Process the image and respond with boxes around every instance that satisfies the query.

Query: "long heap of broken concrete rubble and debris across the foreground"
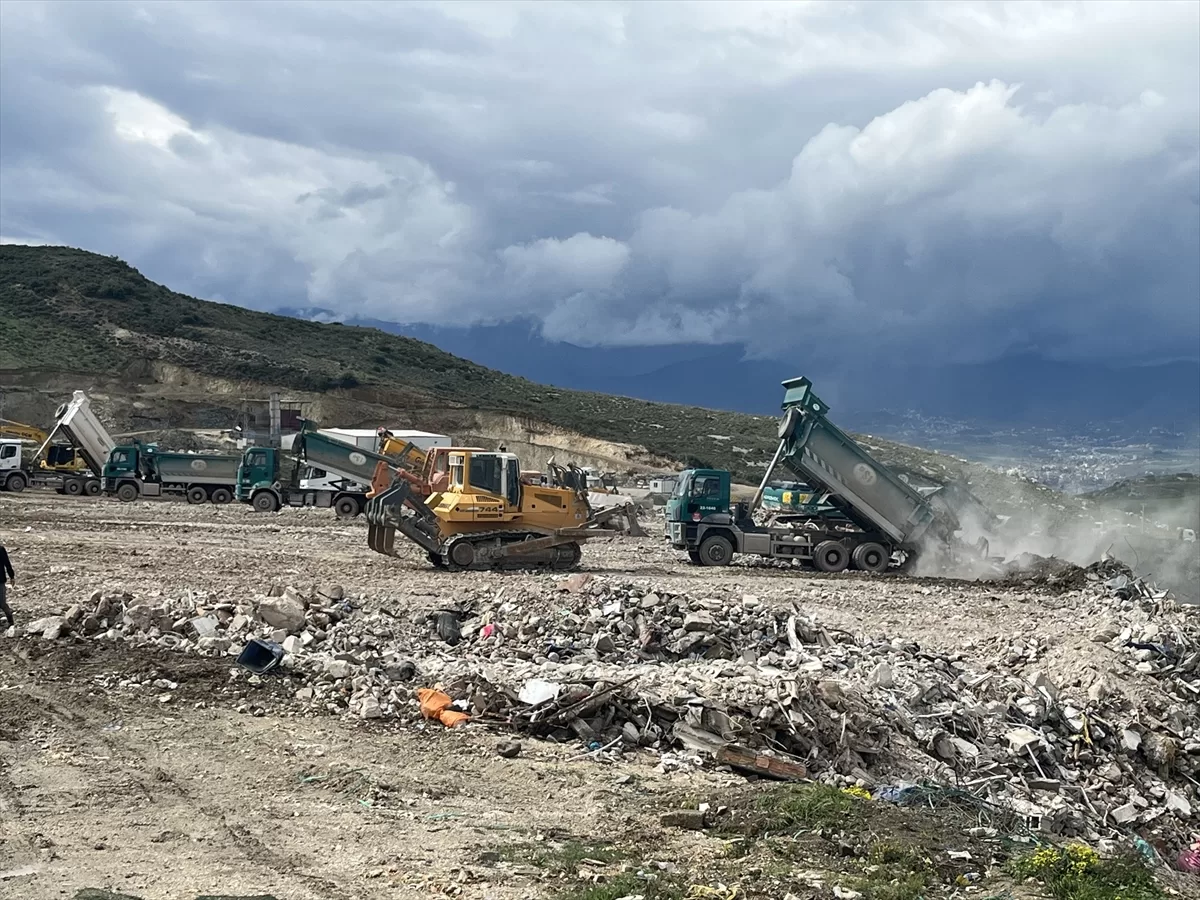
[14,571,1200,844]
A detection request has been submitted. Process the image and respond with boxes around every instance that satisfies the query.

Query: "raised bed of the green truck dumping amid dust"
[779,378,935,545]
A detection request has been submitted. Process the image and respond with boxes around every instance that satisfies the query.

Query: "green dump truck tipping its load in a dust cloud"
[667,378,986,572]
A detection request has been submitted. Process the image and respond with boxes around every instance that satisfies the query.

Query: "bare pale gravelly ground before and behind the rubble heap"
[0,492,1190,900]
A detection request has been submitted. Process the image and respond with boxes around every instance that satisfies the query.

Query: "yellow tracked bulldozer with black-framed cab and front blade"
[366,448,643,571]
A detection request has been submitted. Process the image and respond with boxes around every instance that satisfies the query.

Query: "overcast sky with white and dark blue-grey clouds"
[0,0,1200,361]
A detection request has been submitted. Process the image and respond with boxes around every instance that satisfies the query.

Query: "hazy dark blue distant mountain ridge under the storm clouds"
[284,310,1200,432]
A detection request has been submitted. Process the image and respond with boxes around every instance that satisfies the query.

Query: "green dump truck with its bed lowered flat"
[103,444,241,503]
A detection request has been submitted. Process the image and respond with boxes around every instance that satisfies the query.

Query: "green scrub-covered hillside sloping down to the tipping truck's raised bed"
[0,245,775,479]
